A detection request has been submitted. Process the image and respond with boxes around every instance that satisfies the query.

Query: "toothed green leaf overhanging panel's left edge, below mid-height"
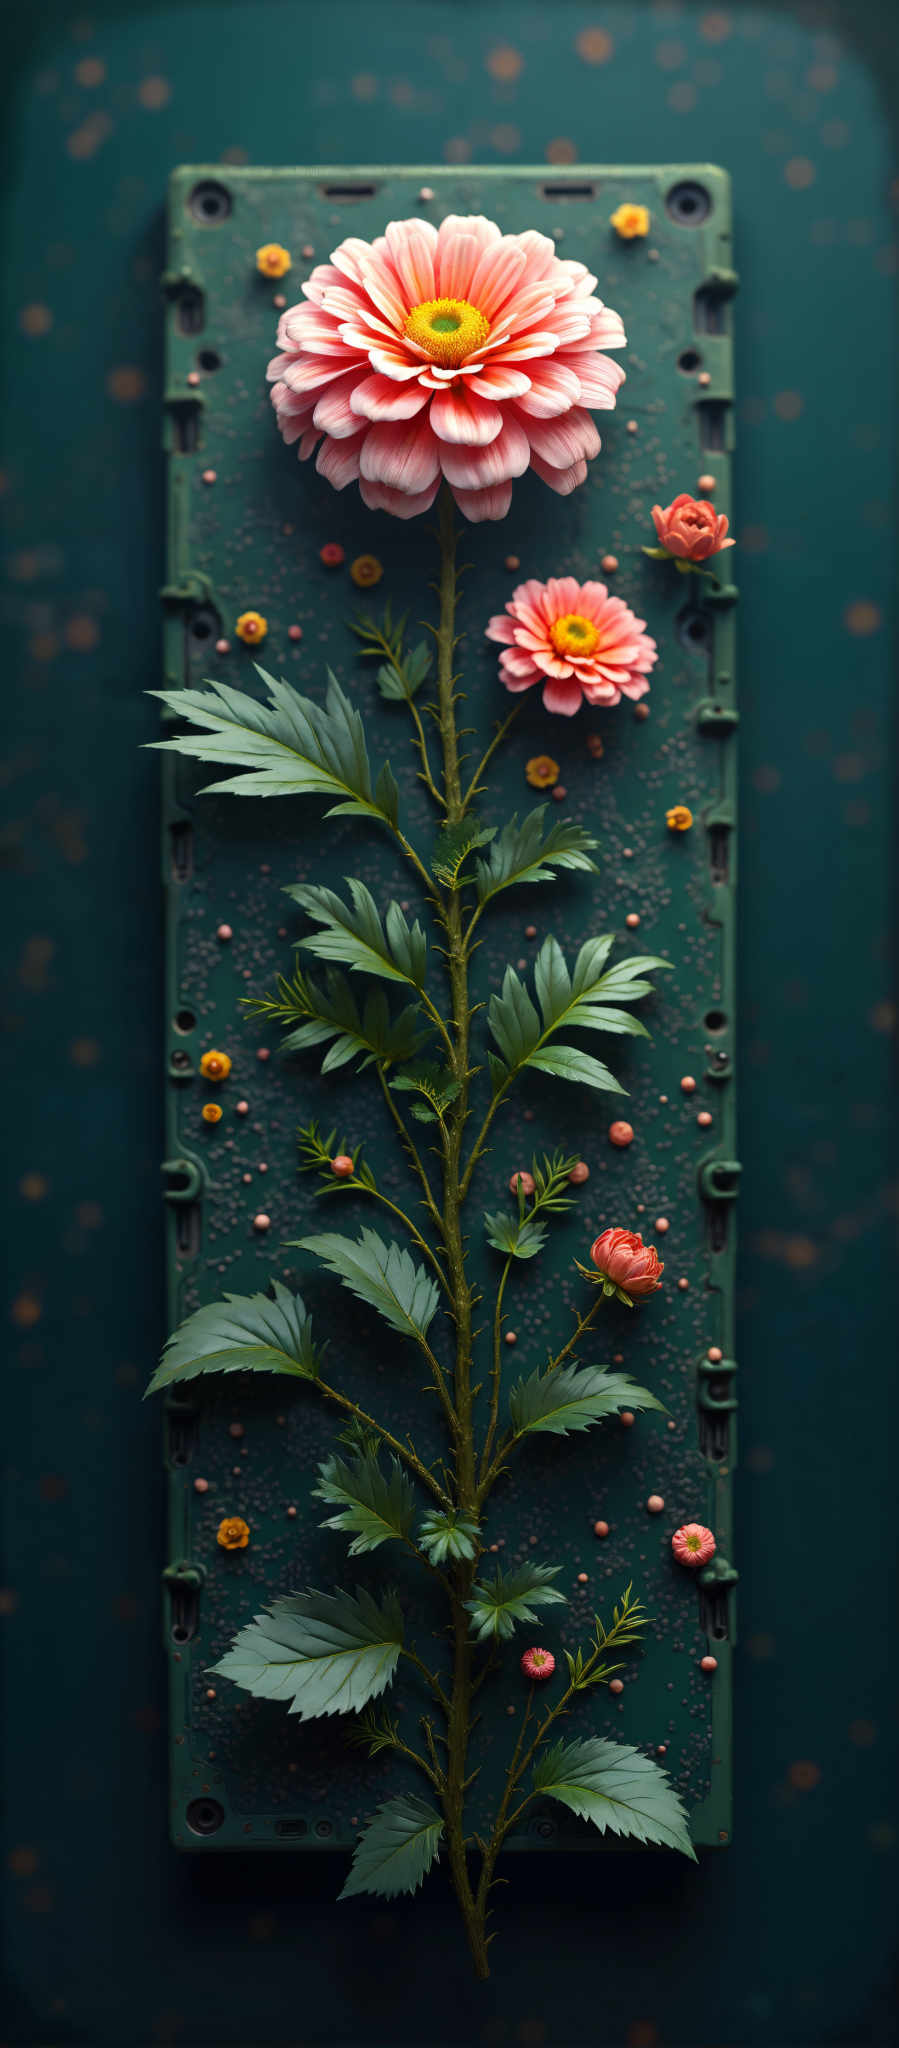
[147,1280,317,1395]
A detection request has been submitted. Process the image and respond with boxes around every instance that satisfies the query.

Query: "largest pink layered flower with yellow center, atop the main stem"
[268,213,625,520]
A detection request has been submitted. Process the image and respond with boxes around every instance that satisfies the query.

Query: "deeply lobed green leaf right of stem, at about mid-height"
[489,936,670,1096]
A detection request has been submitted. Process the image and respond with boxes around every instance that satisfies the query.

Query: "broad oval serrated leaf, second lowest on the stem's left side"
[213,1587,403,1720]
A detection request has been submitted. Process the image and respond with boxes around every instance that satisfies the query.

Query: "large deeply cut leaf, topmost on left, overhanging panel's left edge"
[149,666,395,825]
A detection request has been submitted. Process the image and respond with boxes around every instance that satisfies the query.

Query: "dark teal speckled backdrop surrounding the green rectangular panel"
[0,0,897,2048]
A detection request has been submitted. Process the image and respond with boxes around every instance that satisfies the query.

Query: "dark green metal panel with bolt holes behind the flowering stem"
[164,164,739,1849]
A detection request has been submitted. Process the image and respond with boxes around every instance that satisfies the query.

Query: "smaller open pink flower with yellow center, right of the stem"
[487,575,657,717]
